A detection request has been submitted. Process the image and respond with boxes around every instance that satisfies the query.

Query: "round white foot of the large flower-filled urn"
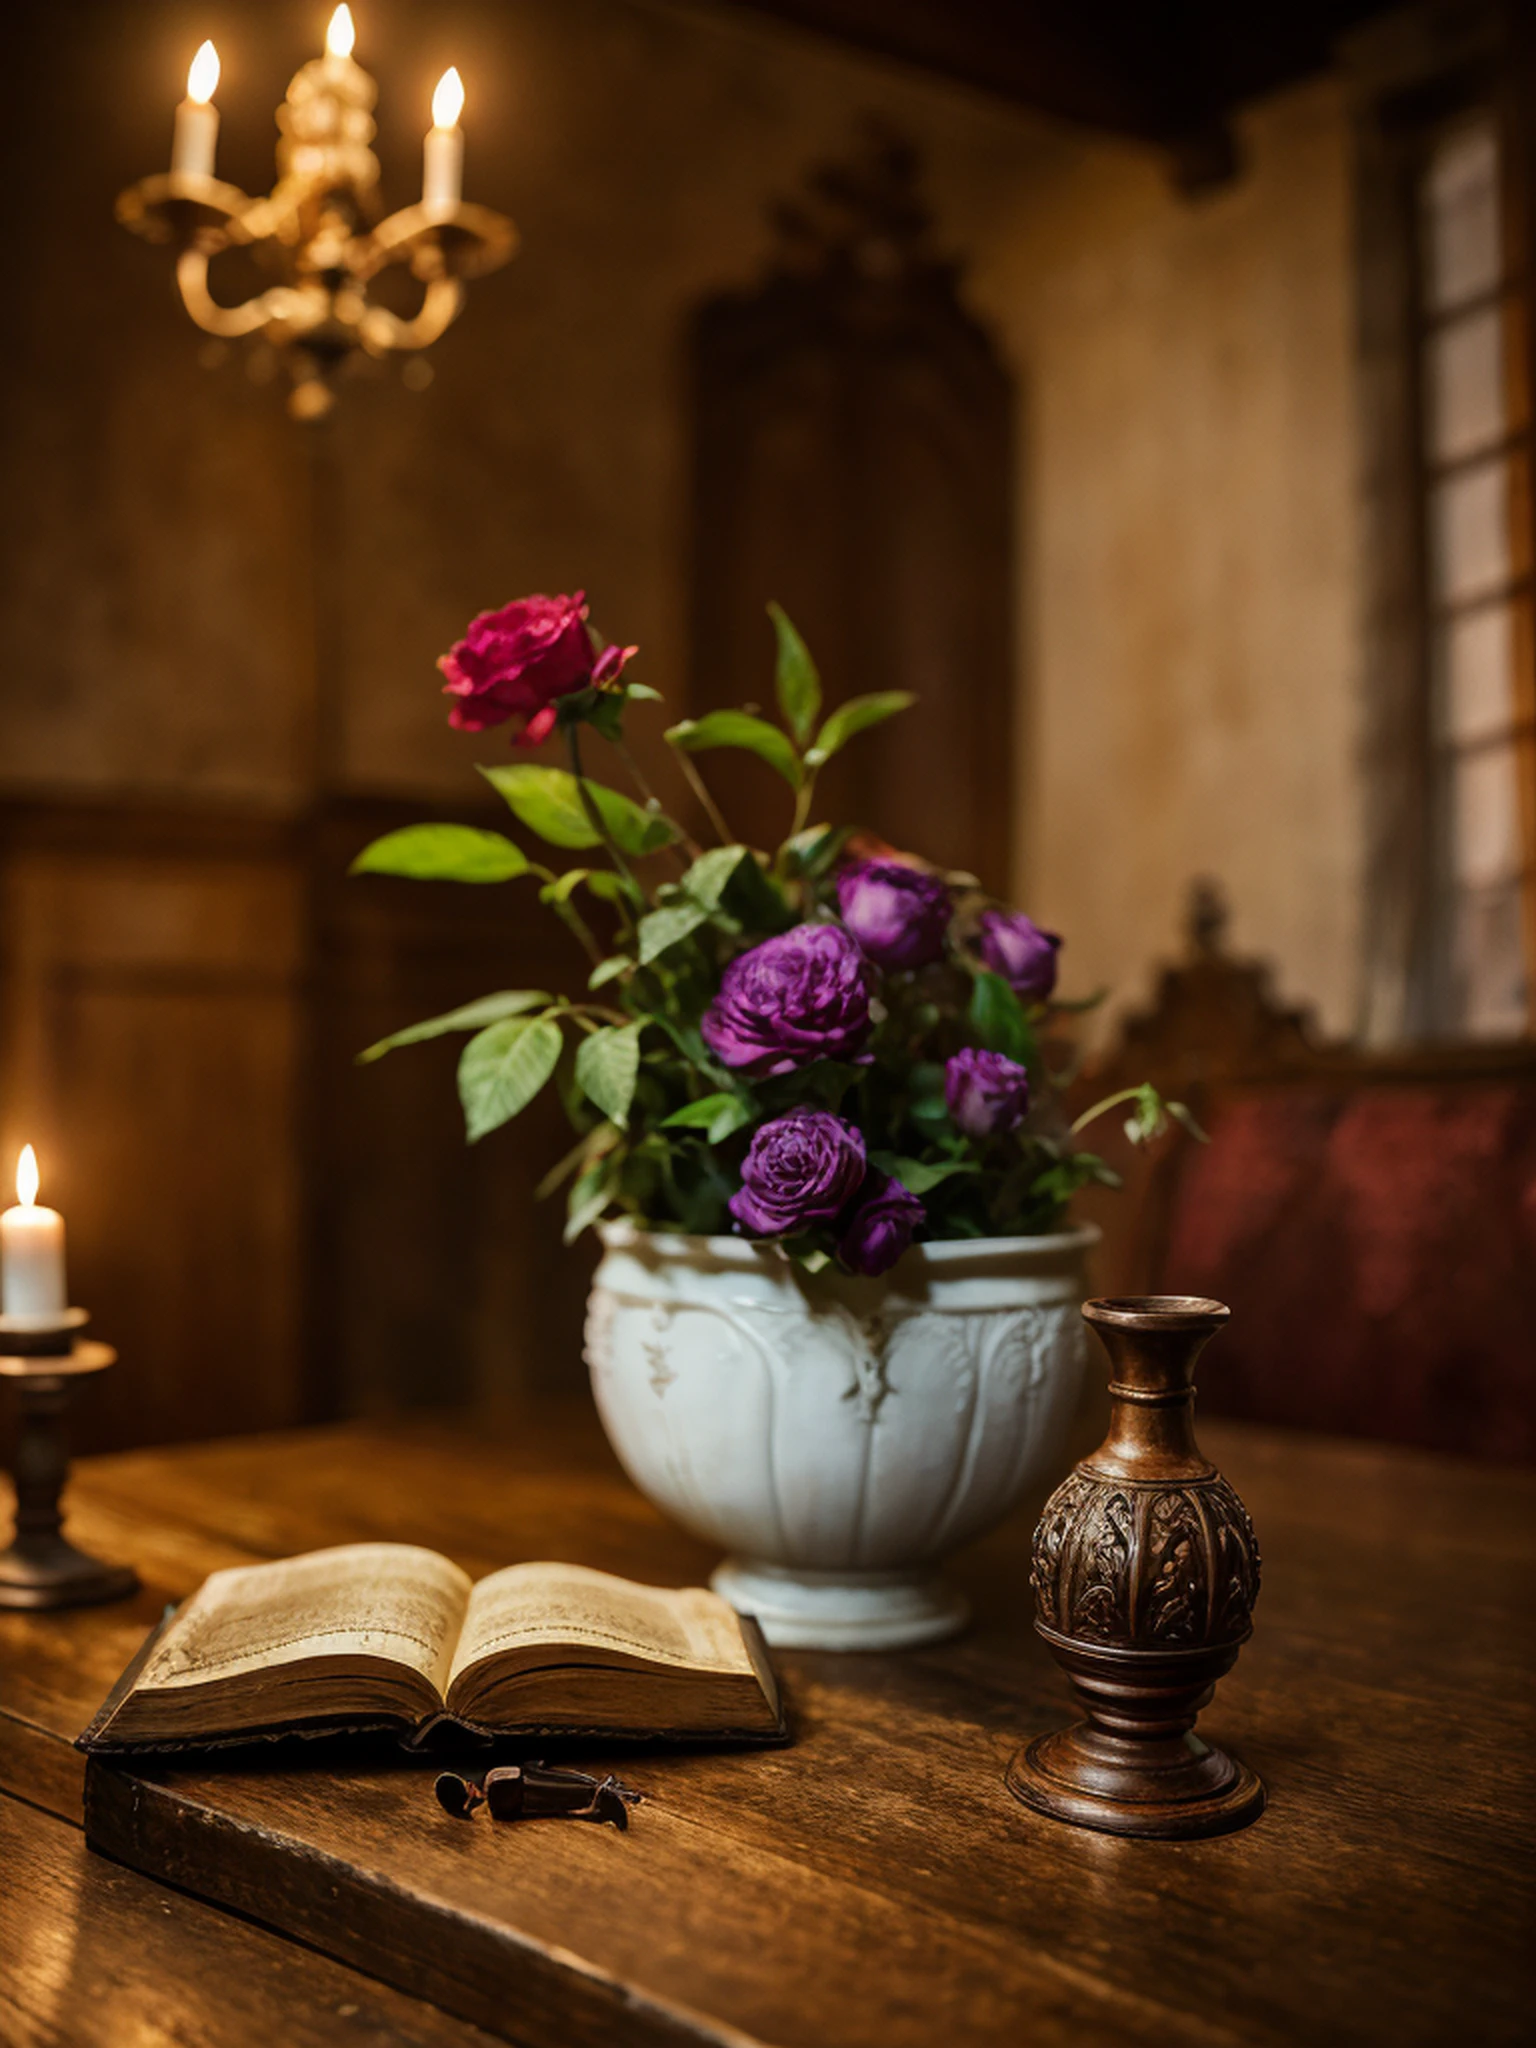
[709,1556,971,1651]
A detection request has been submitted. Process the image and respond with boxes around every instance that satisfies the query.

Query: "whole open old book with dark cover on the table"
[78,1542,784,1753]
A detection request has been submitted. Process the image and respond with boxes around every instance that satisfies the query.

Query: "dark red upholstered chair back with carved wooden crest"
[1083,888,1536,1460]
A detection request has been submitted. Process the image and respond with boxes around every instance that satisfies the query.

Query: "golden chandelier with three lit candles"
[117,6,518,420]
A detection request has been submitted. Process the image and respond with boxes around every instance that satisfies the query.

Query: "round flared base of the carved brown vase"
[1008,1722,1266,1841]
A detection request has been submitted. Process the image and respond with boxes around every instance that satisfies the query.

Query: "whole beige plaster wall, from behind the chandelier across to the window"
[0,0,1358,1026]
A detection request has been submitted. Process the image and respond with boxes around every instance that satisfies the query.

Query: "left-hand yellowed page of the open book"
[135,1542,469,1694]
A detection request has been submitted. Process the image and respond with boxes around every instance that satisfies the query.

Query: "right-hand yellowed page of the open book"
[449,1565,754,1683]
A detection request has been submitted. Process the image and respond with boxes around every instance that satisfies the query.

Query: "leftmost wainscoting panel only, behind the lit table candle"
[0,807,305,1446]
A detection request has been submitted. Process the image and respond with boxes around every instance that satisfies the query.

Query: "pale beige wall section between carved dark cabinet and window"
[977,84,1360,1030]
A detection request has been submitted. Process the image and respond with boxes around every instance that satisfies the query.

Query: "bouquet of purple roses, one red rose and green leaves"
[352,592,1194,1274]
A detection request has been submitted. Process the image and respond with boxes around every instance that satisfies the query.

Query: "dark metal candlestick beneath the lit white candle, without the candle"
[0,1309,139,1608]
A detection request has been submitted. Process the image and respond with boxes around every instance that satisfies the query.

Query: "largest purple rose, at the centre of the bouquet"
[700,924,870,1075]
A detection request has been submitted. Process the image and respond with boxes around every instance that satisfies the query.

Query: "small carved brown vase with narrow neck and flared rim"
[1008,1294,1264,1839]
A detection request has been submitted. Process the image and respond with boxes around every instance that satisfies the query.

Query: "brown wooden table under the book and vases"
[0,1409,1536,2048]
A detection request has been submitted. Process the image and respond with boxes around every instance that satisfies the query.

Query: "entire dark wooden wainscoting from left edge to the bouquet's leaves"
[0,801,590,1448]
